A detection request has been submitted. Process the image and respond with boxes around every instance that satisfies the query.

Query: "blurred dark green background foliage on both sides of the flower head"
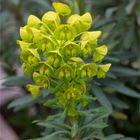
[0,0,140,139]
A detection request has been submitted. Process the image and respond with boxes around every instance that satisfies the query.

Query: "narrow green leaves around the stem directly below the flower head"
[30,107,109,140]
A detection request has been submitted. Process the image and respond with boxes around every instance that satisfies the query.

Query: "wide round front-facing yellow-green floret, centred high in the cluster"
[54,24,76,40]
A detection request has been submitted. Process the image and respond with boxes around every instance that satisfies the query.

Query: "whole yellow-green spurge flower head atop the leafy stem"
[18,2,111,116]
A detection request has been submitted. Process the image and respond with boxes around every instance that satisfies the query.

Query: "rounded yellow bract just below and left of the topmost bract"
[42,11,60,31]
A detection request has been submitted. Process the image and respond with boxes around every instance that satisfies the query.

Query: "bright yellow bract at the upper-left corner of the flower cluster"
[27,15,41,29]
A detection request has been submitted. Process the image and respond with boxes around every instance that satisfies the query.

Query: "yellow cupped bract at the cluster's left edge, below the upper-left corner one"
[20,26,33,42]
